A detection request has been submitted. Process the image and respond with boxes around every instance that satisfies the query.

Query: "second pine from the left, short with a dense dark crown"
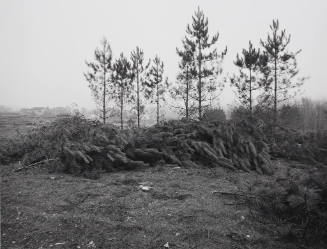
[112,53,134,129]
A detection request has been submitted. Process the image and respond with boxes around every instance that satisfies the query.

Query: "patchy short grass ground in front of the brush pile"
[1,162,323,249]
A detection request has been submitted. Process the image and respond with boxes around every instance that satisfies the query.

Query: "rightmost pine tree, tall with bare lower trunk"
[260,20,305,125]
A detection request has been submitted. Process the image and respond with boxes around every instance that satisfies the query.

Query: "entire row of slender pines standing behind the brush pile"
[84,8,305,129]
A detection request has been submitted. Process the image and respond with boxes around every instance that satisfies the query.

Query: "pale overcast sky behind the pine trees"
[0,0,327,108]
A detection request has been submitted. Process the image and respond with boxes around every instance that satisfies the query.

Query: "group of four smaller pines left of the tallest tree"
[84,42,168,129]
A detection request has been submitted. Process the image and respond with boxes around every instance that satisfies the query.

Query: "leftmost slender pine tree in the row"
[84,38,112,123]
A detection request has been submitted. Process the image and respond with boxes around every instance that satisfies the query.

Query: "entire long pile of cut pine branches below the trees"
[1,116,274,174]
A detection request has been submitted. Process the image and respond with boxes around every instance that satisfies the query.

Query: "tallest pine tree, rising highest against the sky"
[185,8,227,120]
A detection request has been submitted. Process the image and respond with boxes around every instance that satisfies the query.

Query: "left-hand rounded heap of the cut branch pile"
[1,115,144,174]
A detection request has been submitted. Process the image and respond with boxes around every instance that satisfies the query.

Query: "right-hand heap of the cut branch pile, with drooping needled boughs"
[128,120,273,174]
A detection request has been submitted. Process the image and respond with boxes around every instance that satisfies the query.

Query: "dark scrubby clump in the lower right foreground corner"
[248,163,327,243]
